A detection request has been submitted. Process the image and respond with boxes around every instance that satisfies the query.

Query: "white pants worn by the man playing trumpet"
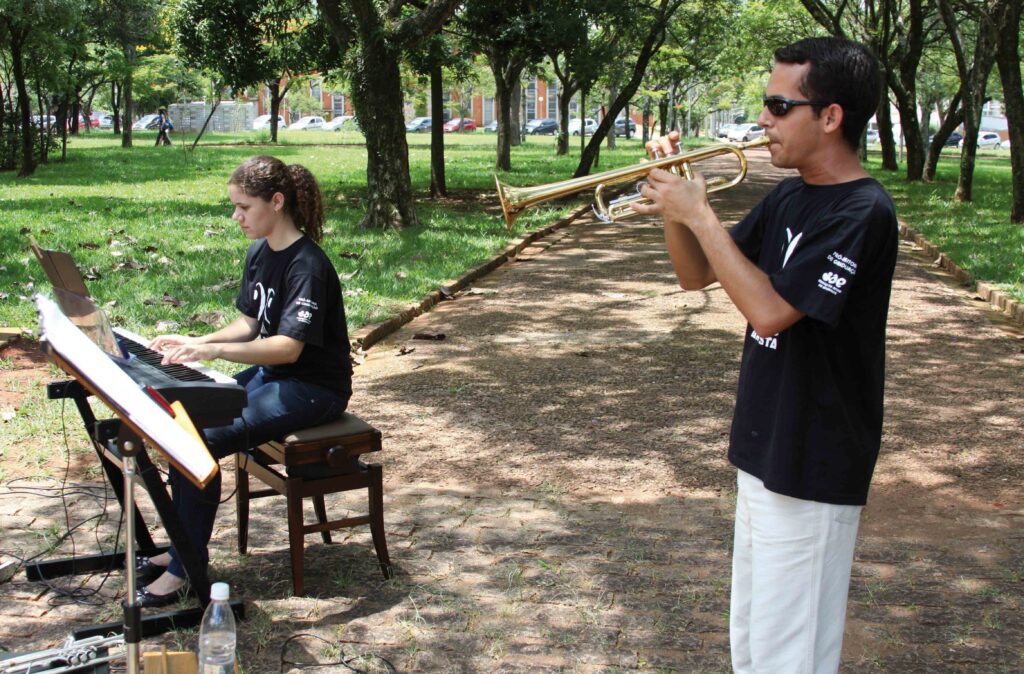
[729,470,861,674]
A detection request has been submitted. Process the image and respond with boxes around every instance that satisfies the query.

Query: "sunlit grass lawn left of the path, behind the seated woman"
[0,131,641,334]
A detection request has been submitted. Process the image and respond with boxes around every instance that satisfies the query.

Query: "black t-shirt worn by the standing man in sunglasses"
[729,177,898,505]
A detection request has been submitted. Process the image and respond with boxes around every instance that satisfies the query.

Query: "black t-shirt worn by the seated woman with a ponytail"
[234,237,352,396]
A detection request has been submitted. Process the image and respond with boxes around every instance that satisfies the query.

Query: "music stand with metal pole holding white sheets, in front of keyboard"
[35,296,219,674]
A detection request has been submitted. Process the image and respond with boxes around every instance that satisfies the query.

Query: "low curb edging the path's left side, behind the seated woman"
[349,205,591,350]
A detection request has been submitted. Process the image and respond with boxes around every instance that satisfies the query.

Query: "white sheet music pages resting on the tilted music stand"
[36,295,217,482]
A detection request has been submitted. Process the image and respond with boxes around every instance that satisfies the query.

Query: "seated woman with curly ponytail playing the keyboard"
[136,156,352,606]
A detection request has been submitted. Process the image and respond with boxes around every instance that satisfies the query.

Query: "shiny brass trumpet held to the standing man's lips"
[495,136,771,229]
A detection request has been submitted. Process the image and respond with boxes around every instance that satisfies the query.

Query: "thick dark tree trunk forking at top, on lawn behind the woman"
[317,0,459,229]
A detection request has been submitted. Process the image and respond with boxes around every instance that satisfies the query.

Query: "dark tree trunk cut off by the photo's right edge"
[995,2,1024,223]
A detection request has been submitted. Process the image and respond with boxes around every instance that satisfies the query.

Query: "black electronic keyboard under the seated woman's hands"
[115,334,248,428]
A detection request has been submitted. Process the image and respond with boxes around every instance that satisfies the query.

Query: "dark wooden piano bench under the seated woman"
[234,412,392,595]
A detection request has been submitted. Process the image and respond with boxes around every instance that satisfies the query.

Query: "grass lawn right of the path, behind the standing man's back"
[867,151,1024,302]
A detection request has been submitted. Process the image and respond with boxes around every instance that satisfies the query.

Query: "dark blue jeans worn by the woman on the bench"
[168,366,348,578]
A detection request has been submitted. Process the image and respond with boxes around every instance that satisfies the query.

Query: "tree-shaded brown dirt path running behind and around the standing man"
[0,149,1024,673]
